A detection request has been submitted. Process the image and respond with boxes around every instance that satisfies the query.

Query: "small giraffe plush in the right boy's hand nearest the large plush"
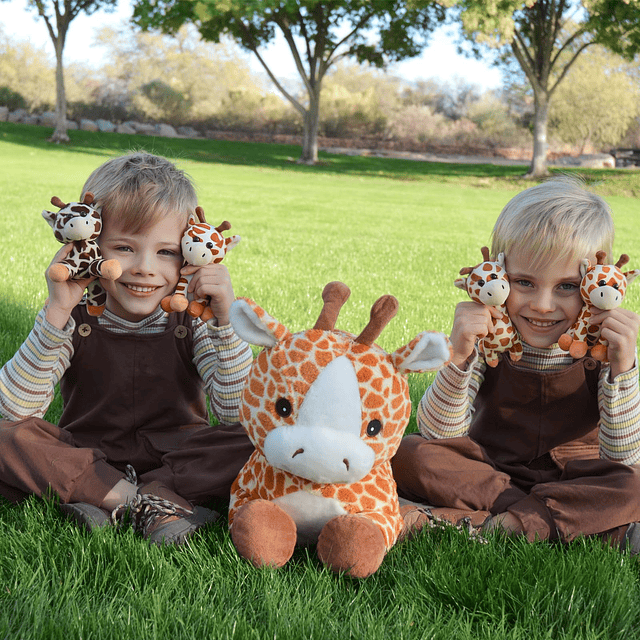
[454,247,522,367]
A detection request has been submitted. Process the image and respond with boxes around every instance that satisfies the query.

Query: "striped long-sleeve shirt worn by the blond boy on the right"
[417,343,640,465]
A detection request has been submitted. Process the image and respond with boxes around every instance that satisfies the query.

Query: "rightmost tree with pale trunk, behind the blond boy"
[440,0,640,177]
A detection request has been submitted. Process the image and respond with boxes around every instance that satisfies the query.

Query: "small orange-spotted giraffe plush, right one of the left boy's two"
[160,207,240,322]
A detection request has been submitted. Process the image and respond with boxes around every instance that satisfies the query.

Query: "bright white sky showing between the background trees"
[0,0,501,89]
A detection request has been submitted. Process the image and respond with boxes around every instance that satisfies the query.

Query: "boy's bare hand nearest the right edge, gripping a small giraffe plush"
[592,308,640,380]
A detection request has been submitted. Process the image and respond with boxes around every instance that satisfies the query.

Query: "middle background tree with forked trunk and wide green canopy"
[134,0,444,162]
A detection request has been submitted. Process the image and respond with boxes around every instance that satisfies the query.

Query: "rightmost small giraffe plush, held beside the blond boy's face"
[558,251,640,362]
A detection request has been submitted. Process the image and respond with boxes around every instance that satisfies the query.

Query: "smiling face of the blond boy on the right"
[506,252,582,348]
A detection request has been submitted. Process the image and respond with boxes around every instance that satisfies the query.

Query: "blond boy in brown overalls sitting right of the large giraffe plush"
[393,179,640,554]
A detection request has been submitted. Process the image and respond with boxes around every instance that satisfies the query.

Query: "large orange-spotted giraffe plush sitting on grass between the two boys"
[229,282,450,578]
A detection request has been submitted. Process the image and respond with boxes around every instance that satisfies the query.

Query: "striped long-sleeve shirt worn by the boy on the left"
[0,309,252,423]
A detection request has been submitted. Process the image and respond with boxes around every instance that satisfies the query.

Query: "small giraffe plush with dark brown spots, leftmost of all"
[42,193,122,316]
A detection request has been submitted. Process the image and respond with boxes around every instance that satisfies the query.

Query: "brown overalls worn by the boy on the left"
[0,306,253,506]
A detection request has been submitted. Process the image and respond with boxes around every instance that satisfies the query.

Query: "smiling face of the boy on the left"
[98,216,184,322]
